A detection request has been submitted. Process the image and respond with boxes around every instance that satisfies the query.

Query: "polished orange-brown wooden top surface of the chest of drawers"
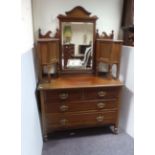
[38,75,123,90]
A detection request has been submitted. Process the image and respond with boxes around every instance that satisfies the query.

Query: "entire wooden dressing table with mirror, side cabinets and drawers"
[37,6,123,141]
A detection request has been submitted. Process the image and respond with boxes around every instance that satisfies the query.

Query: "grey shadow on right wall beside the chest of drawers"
[120,86,134,129]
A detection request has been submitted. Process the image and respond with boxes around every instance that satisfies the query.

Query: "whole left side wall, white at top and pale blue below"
[21,0,43,155]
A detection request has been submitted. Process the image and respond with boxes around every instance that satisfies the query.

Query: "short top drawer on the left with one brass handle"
[45,89,82,103]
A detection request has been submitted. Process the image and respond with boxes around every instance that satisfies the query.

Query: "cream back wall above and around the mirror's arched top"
[32,0,123,38]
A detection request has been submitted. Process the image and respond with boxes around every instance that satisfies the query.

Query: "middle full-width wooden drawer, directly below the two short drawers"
[45,99,118,113]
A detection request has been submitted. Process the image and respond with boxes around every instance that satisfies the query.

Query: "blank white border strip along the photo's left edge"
[0,0,21,155]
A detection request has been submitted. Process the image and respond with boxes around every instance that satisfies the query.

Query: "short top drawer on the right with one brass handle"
[84,87,119,99]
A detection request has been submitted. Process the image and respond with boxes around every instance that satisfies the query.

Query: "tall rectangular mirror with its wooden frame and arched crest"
[58,6,97,72]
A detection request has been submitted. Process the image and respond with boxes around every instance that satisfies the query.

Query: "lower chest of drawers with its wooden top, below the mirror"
[38,75,123,139]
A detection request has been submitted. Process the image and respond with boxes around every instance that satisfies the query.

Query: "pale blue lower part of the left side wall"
[21,49,43,155]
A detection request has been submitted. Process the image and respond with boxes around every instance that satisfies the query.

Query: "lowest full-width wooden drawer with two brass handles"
[46,111,117,128]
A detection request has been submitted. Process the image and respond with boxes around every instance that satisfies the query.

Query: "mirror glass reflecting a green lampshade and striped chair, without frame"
[61,22,93,70]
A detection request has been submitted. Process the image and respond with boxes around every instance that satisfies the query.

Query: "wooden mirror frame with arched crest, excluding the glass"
[57,6,98,73]
